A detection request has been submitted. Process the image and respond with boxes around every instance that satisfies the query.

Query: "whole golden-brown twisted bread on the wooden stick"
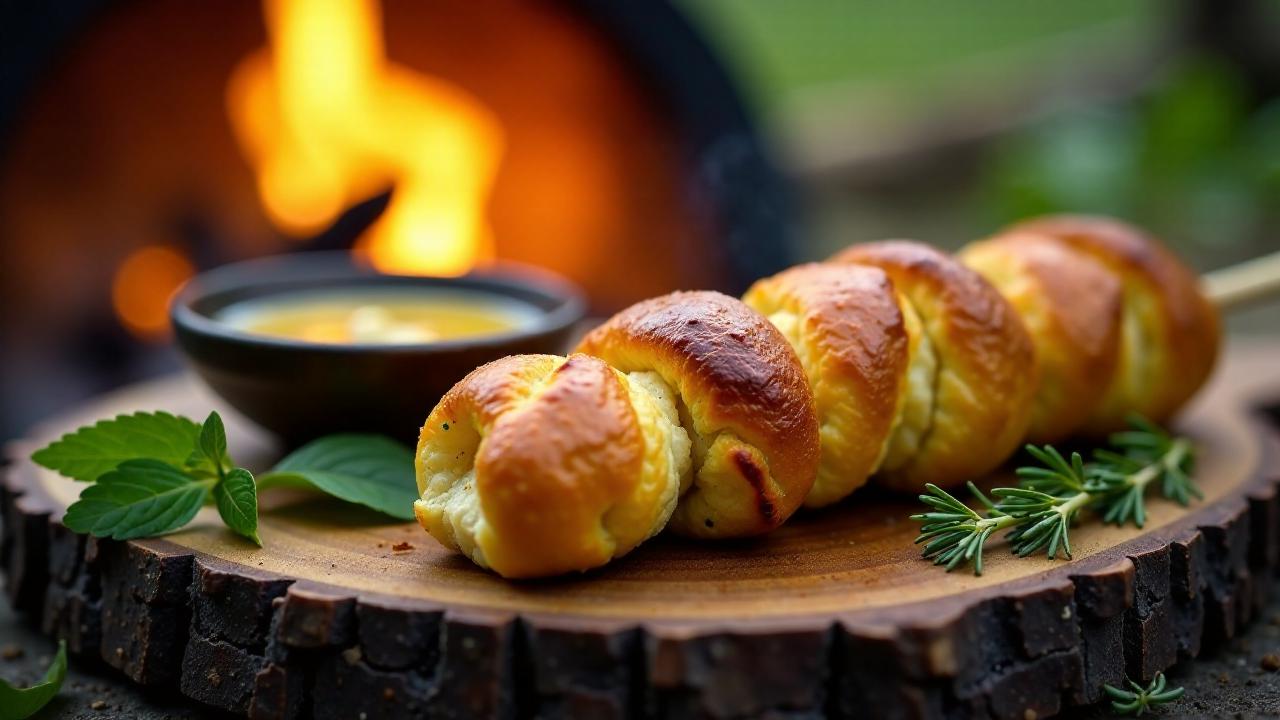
[415,217,1220,577]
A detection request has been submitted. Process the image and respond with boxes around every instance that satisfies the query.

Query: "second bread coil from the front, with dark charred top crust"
[579,291,818,537]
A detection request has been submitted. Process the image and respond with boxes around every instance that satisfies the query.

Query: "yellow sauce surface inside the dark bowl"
[216,290,543,345]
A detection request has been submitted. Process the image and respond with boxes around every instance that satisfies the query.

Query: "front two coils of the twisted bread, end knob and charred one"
[415,292,818,578]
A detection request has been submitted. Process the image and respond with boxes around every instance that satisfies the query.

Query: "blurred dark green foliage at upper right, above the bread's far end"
[979,59,1280,252]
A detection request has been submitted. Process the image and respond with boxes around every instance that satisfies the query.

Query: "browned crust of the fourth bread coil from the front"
[833,241,1038,491]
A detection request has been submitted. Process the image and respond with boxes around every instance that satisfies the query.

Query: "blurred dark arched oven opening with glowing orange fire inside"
[0,0,795,437]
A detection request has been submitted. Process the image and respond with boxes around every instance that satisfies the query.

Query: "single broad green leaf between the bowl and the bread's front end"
[257,434,417,520]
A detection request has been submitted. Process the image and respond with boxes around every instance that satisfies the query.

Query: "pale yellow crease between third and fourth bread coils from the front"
[878,292,938,470]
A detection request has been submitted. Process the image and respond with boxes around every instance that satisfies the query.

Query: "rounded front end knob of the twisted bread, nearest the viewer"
[415,355,678,578]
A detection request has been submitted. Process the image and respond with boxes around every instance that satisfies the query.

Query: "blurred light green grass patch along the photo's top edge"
[677,0,1169,114]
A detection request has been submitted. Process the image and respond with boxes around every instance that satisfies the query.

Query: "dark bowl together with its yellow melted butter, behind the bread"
[170,251,586,447]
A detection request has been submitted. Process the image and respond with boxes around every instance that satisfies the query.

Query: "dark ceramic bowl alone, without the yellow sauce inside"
[172,252,584,445]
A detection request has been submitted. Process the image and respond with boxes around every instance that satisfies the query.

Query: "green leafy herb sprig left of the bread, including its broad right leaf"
[31,411,417,547]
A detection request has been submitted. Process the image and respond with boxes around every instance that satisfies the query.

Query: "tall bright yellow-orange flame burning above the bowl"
[228,0,503,275]
